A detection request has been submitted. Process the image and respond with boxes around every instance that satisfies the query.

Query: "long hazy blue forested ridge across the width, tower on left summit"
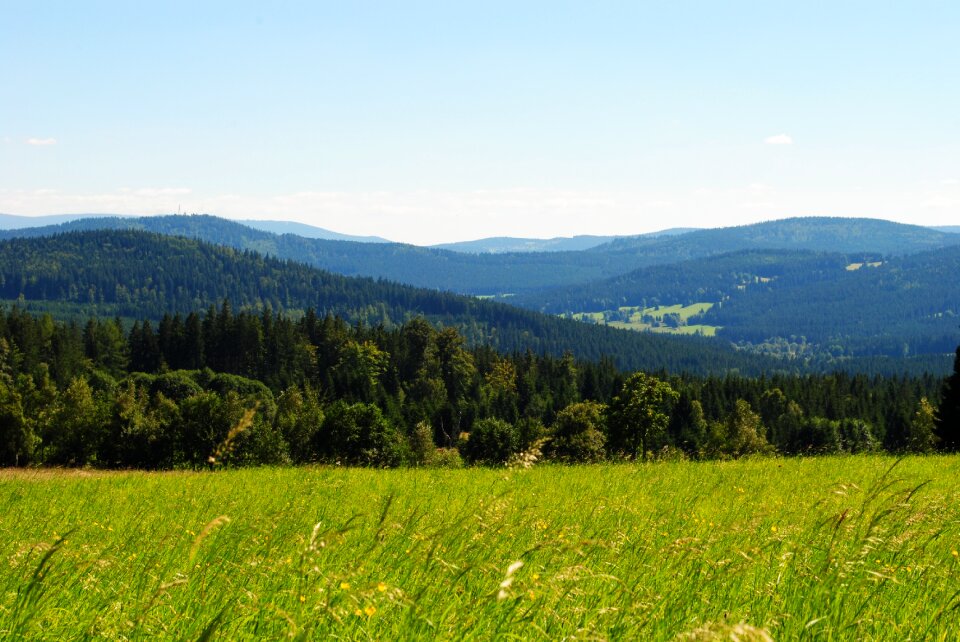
[0,216,960,294]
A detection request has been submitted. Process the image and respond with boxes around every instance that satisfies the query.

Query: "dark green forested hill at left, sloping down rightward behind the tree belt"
[0,230,782,374]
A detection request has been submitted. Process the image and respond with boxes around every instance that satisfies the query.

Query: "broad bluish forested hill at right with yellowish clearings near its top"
[512,245,960,367]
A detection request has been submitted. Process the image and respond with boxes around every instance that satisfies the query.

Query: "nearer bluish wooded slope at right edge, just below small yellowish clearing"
[705,246,960,356]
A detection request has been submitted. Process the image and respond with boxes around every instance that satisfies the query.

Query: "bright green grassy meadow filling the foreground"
[0,457,960,640]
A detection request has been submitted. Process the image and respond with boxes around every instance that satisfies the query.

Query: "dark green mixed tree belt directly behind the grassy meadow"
[0,300,960,469]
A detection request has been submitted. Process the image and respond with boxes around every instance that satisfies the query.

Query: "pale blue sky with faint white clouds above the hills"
[0,0,960,244]
